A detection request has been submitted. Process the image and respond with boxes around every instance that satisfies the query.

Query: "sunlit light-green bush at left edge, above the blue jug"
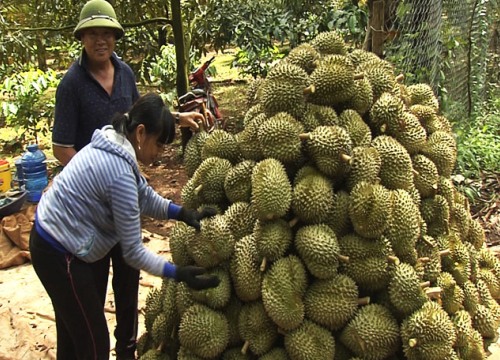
[0,70,59,143]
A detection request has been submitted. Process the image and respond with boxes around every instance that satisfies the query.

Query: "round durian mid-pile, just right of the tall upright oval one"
[291,173,334,224]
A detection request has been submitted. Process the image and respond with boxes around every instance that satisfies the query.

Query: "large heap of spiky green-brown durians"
[138,31,500,360]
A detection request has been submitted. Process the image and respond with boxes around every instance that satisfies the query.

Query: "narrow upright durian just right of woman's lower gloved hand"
[230,234,263,301]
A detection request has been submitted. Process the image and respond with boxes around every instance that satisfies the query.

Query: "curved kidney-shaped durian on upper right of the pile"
[372,135,413,190]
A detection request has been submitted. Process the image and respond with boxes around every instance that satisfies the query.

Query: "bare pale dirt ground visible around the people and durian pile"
[0,134,500,360]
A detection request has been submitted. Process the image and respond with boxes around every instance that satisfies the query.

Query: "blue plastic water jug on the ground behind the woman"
[21,144,48,203]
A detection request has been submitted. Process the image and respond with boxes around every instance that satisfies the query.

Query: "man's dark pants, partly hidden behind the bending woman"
[91,244,139,359]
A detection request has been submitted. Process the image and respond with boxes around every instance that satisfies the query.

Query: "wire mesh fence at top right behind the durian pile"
[385,0,498,116]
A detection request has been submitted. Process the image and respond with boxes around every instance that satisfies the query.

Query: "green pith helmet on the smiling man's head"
[73,0,124,40]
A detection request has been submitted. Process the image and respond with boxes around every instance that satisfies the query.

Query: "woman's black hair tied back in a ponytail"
[112,93,175,144]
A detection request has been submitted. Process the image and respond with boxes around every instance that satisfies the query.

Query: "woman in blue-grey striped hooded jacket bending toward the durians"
[30,94,219,359]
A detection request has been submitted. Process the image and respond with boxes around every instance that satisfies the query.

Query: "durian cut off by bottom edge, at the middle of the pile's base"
[285,320,335,360]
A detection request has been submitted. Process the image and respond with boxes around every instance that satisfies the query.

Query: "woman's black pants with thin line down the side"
[30,226,109,360]
